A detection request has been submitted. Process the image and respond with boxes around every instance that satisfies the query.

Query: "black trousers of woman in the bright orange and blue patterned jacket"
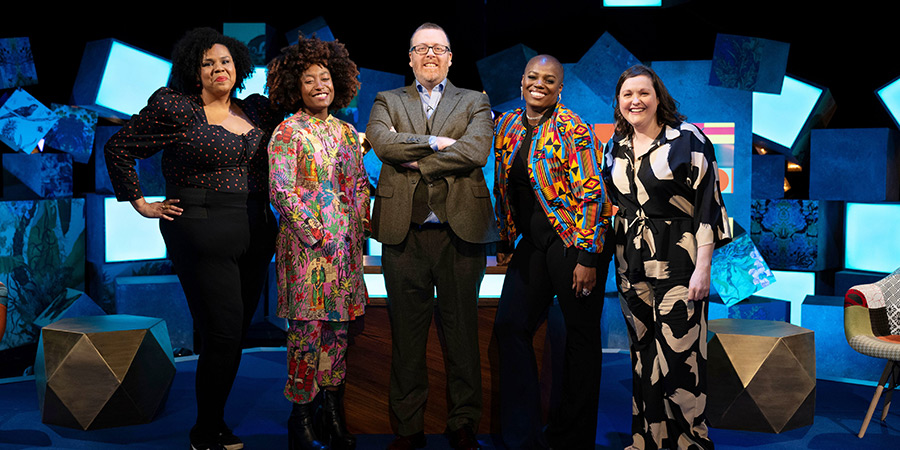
[494,237,609,449]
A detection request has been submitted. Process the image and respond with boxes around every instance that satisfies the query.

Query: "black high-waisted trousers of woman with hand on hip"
[159,188,278,435]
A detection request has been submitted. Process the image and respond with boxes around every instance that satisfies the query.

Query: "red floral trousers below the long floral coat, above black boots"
[284,320,349,404]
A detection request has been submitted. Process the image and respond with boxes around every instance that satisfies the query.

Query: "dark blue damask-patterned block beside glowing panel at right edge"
[750,199,843,271]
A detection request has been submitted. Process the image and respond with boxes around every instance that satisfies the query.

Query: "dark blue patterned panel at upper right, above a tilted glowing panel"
[709,34,790,94]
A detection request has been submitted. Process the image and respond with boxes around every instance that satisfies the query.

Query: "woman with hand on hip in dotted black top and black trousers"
[105,28,279,450]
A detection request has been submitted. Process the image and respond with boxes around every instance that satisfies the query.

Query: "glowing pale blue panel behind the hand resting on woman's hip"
[103,197,166,263]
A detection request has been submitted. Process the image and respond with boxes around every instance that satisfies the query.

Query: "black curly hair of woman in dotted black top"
[169,28,253,95]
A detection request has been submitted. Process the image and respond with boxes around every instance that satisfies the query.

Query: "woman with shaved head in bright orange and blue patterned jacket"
[494,55,610,449]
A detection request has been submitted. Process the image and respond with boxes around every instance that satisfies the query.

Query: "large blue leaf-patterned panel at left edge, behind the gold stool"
[0,199,85,350]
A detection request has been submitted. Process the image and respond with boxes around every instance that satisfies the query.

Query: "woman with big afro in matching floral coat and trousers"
[268,35,369,450]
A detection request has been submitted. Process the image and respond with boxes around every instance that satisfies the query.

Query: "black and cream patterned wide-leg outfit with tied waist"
[604,123,731,449]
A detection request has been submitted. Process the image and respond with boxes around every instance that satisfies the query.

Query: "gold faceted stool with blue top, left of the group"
[35,315,175,430]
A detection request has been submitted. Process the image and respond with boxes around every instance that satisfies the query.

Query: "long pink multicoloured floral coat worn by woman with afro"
[269,111,369,321]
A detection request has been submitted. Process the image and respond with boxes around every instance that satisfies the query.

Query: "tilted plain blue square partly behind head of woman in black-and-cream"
[574,32,640,105]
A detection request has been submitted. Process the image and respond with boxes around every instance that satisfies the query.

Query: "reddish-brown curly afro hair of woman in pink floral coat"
[266,33,360,114]
